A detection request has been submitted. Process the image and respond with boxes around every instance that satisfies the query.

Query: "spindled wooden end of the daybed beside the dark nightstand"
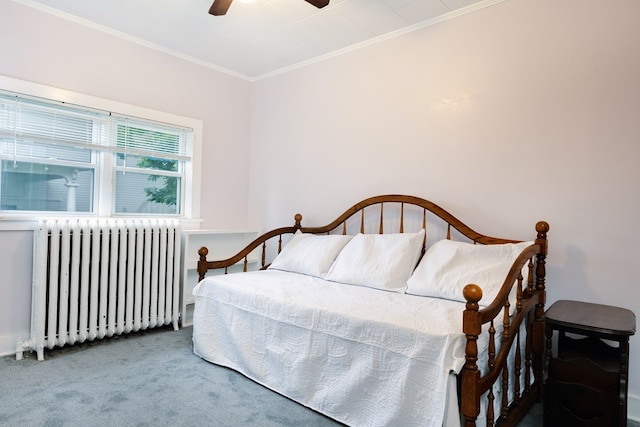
[460,221,549,426]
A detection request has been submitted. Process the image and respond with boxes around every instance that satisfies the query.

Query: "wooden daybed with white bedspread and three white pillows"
[193,195,549,427]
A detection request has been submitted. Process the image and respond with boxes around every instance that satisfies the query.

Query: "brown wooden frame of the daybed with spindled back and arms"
[198,195,549,426]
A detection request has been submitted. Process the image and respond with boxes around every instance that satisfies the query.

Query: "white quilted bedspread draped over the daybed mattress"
[193,270,465,427]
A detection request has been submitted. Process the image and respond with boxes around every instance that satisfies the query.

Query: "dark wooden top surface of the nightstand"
[545,300,636,336]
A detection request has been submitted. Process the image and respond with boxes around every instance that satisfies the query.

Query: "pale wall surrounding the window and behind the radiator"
[0,1,251,354]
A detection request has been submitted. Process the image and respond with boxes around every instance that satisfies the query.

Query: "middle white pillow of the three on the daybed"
[325,230,424,293]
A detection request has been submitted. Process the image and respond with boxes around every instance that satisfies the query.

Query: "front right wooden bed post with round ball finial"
[460,284,482,427]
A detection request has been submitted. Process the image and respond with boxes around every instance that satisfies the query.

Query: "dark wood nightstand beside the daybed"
[544,300,636,426]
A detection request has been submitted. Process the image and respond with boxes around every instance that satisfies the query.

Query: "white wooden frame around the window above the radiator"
[0,75,202,221]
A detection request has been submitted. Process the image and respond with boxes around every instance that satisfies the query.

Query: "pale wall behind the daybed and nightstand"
[250,0,640,418]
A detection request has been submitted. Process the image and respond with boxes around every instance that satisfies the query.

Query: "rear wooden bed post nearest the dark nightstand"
[532,221,549,400]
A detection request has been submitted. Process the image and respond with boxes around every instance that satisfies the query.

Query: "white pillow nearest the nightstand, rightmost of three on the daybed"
[407,239,533,306]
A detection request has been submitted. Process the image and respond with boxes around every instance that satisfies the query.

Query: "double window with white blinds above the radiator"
[0,92,193,216]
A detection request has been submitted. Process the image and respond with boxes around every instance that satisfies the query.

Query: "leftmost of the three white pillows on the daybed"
[269,230,353,277]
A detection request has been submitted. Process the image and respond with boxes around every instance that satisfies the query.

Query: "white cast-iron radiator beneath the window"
[16,219,180,360]
